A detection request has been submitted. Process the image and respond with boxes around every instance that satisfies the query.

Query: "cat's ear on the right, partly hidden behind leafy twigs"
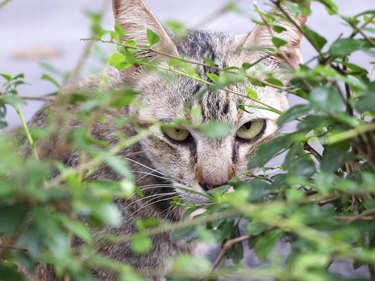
[243,1,309,67]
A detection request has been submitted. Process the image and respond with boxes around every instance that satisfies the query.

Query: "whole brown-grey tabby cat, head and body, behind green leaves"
[26,0,306,281]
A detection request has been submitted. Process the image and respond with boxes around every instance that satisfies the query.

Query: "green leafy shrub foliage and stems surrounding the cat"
[0,0,375,281]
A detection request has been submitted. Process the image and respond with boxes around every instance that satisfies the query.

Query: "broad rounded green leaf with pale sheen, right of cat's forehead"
[310,86,346,113]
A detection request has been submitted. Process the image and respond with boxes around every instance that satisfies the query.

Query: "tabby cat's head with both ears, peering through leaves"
[113,0,304,202]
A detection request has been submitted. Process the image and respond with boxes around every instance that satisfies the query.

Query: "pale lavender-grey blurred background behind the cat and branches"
[0,0,375,127]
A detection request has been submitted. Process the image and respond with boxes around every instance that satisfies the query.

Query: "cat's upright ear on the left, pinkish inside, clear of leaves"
[112,0,178,58]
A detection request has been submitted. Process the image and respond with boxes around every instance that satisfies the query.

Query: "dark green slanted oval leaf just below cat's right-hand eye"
[247,135,292,169]
